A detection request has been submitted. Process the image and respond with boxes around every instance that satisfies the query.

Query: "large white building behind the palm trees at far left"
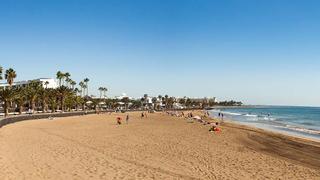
[0,78,59,88]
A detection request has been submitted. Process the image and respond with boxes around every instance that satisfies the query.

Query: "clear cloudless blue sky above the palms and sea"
[0,0,320,106]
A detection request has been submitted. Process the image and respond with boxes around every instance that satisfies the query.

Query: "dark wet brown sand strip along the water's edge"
[222,121,320,168]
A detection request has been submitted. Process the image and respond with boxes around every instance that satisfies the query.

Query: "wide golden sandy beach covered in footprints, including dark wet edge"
[0,112,320,179]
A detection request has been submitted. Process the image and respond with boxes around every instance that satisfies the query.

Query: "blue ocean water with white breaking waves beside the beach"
[211,106,320,141]
